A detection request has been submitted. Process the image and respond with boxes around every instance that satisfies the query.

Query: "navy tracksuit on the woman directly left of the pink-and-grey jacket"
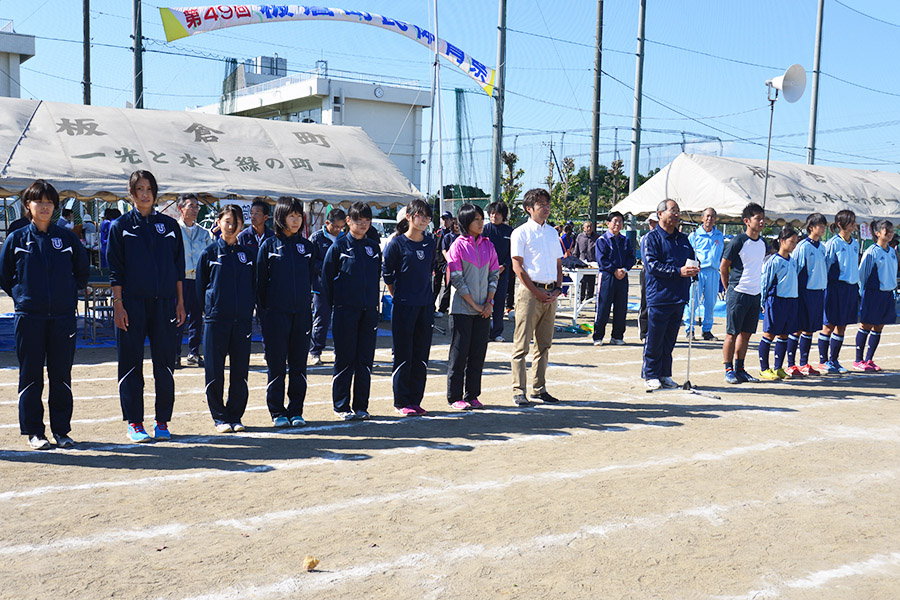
[382,235,434,408]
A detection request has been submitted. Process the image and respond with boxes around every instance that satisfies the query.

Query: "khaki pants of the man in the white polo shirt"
[512,285,556,394]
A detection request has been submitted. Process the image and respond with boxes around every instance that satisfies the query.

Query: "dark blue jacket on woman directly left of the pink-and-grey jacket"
[382,233,434,306]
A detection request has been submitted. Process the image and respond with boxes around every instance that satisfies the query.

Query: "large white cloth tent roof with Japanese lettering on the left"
[0,98,422,205]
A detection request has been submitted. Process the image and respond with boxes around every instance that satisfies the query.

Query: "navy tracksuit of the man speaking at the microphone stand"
[641,225,694,379]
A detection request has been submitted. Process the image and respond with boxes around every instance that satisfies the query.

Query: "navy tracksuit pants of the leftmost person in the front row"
[15,315,78,437]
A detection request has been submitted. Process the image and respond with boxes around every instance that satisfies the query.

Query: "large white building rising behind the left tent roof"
[195,55,431,189]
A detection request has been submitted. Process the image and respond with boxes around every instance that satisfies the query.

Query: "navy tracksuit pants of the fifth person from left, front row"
[331,306,379,412]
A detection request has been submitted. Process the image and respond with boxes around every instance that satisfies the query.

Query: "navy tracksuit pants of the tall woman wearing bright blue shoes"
[116,298,176,423]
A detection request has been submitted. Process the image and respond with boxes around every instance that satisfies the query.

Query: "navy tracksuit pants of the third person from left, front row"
[203,319,252,425]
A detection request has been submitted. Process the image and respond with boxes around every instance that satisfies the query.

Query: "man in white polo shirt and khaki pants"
[510,188,563,406]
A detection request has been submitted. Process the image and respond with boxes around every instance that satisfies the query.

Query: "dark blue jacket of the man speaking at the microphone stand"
[642,225,694,306]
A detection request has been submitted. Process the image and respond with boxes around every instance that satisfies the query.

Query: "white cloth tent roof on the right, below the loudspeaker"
[613,154,900,222]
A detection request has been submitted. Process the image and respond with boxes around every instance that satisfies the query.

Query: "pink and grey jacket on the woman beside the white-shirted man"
[447,235,500,315]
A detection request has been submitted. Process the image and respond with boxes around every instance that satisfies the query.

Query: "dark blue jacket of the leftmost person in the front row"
[0,223,89,318]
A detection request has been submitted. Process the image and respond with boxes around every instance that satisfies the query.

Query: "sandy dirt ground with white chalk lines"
[0,282,900,600]
